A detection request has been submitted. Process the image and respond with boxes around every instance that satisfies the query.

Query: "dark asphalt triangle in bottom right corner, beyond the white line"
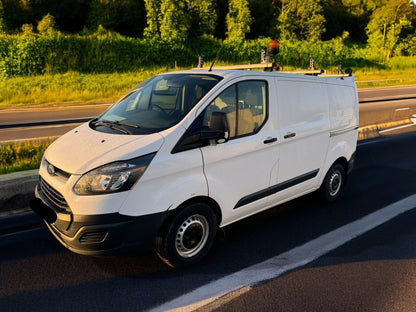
[214,210,416,312]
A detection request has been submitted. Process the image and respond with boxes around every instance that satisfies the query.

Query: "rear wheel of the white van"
[320,163,346,202]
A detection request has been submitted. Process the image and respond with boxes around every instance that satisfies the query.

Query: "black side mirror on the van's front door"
[200,112,230,144]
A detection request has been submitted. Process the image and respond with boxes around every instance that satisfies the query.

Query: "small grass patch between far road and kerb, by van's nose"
[0,141,52,174]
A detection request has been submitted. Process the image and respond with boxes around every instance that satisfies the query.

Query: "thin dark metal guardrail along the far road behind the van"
[0,96,416,130]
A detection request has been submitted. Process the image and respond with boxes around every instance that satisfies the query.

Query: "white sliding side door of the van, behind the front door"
[275,78,330,200]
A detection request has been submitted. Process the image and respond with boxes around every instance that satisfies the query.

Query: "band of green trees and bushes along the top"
[0,0,416,70]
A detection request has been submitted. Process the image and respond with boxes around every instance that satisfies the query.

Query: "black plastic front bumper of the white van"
[30,185,167,256]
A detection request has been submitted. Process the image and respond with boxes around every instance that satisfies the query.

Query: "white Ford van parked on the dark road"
[31,69,358,267]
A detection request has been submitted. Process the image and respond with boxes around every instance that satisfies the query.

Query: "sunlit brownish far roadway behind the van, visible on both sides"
[0,86,416,142]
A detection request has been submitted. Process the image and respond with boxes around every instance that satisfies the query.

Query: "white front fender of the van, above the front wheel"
[119,127,208,216]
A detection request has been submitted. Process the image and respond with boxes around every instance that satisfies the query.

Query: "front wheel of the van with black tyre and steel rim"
[156,203,218,268]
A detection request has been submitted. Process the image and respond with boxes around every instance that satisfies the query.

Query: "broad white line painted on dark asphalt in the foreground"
[149,194,416,312]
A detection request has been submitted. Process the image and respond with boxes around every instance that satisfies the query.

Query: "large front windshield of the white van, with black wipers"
[90,74,222,134]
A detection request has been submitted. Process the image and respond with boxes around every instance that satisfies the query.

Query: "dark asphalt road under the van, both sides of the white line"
[0,132,416,312]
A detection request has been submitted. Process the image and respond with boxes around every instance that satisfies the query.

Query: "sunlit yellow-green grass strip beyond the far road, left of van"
[0,67,167,108]
